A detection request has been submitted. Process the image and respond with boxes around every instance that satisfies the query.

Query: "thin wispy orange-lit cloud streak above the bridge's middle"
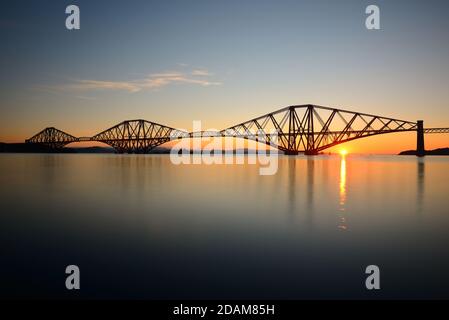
[64,70,221,93]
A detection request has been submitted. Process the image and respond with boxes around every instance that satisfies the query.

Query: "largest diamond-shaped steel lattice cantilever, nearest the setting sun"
[221,105,416,153]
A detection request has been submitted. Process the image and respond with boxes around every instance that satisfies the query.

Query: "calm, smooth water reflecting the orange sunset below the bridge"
[0,154,449,299]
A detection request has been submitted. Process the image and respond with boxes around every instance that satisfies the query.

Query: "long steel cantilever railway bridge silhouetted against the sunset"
[25,104,449,156]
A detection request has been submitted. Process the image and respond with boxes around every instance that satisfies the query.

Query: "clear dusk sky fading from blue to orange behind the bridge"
[0,0,449,153]
